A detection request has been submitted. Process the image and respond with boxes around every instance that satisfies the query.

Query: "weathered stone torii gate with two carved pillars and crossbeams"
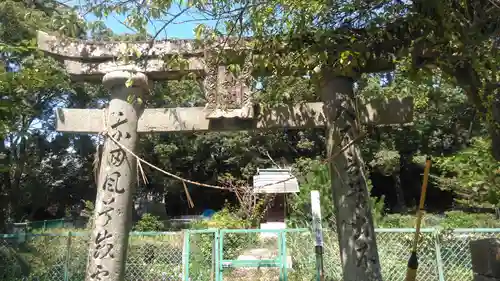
[38,32,413,281]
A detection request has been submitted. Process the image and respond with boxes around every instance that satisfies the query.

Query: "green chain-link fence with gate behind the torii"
[0,229,500,281]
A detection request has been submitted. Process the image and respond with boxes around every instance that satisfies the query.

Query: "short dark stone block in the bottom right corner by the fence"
[469,238,500,281]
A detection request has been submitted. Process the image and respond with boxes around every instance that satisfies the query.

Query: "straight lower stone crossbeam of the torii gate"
[56,98,413,133]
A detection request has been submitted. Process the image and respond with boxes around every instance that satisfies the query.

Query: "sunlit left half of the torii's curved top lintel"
[37,31,250,82]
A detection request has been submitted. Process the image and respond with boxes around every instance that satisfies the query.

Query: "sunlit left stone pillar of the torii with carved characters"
[85,71,148,281]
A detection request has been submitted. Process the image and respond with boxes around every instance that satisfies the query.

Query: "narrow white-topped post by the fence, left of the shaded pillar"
[311,190,325,281]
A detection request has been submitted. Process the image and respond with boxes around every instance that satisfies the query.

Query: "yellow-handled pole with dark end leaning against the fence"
[405,157,431,281]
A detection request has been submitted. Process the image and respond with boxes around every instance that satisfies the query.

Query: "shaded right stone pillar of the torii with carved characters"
[321,73,382,281]
